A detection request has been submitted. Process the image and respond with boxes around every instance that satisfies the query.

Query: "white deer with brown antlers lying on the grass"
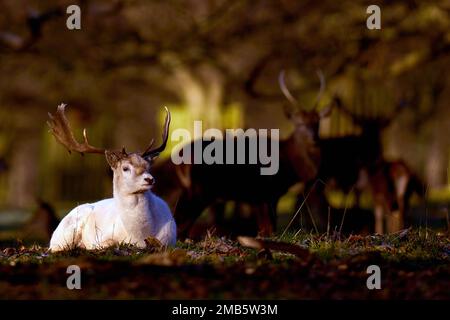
[48,104,176,251]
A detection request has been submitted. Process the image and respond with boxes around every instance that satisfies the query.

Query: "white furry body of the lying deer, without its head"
[50,191,176,251]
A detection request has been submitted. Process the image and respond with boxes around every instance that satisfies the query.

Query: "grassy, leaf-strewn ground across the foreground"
[0,229,450,299]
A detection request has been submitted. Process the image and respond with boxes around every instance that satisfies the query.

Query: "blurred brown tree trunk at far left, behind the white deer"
[7,130,40,208]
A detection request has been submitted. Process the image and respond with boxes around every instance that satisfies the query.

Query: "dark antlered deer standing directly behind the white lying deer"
[175,72,331,238]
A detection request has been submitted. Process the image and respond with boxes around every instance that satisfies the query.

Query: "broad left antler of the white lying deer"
[47,103,106,154]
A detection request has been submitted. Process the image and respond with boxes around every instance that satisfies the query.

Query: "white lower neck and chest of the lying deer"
[114,186,156,240]
